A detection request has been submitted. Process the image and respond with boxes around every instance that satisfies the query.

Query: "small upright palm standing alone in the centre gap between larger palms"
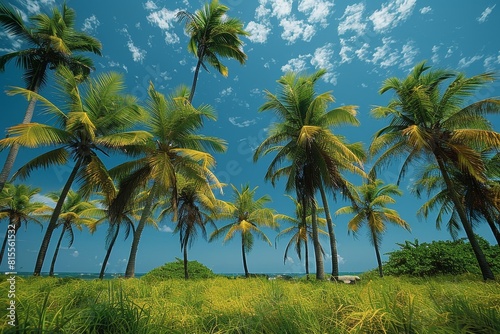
[209,184,278,277]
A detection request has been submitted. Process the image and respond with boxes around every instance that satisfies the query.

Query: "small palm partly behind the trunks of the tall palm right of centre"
[276,195,328,279]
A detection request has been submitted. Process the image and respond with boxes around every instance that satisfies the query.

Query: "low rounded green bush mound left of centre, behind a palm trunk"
[141,258,216,281]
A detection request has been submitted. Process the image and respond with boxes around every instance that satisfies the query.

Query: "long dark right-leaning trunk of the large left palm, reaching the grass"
[33,158,83,276]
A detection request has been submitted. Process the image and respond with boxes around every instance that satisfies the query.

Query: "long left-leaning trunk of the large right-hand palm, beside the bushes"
[435,154,495,281]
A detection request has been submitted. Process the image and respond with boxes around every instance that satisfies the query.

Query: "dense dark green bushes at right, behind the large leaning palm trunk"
[384,236,500,277]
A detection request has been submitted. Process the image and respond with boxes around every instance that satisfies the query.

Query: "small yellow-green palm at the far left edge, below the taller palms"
[0,183,50,264]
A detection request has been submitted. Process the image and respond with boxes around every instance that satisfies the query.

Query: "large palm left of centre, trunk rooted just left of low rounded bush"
[110,84,226,277]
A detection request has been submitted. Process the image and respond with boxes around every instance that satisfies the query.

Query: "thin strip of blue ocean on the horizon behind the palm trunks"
[5,272,362,280]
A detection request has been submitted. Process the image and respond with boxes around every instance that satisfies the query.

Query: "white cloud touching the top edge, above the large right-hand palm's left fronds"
[369,0,417,33]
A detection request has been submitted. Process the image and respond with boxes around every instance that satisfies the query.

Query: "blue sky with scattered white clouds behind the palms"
[0,0,500,273]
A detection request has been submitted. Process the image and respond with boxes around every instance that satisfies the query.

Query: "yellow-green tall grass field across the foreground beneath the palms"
[0,275,500,334]
